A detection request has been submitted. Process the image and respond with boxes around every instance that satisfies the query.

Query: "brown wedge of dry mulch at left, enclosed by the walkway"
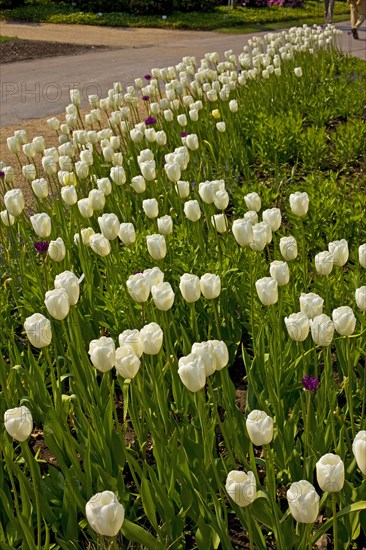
[0,39,111,63]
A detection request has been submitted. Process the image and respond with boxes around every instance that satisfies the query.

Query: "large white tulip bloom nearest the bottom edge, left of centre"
[85,491,125,537]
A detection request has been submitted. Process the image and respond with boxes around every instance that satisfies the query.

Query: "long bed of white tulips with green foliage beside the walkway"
[0,26,366,550]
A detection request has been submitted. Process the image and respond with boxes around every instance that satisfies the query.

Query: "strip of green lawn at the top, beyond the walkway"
[0,0,349,32]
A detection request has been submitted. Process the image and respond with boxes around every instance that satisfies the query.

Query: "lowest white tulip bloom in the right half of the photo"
[286,479,319,523]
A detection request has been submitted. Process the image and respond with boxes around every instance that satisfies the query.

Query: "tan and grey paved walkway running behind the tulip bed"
[0,21,366,126]
